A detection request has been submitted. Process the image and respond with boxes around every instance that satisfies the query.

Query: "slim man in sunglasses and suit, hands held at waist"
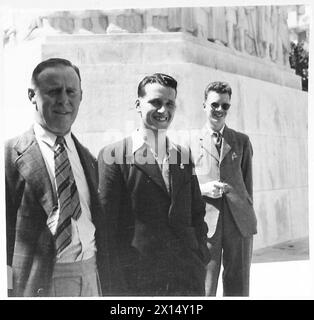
[191,82,256,296]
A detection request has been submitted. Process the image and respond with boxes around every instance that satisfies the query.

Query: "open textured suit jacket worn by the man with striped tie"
[5,129,104,296]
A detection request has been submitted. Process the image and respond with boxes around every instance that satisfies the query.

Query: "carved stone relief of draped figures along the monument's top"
[4,5,290,65]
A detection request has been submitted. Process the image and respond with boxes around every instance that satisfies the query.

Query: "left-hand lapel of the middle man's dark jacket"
[134,144,169,196]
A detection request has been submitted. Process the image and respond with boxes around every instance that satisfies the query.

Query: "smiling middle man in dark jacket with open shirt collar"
[98,73,209,296]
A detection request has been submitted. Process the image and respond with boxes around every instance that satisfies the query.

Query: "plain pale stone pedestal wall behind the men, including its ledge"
[4,7,308,254]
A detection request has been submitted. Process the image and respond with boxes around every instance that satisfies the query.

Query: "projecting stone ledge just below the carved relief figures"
[40,32,301,89]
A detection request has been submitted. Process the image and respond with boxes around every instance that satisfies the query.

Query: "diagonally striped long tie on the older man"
[54,137,82,254]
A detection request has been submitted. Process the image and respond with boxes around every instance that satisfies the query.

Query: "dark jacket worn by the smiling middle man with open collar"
[98,137,209,295]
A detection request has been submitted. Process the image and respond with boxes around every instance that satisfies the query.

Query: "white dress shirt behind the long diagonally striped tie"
[34,123,96,263]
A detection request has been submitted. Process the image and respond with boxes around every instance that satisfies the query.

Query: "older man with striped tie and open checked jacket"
[5,58,104,296]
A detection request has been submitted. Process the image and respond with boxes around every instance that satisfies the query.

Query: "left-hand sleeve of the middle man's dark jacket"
[98,148,127,296]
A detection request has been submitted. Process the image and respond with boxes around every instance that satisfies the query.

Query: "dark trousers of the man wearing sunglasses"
[205,199,253,296]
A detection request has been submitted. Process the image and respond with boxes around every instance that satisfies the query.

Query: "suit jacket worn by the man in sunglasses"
[191,126,257,237]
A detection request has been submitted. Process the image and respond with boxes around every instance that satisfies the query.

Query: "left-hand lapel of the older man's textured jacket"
[14,128,57,215]
